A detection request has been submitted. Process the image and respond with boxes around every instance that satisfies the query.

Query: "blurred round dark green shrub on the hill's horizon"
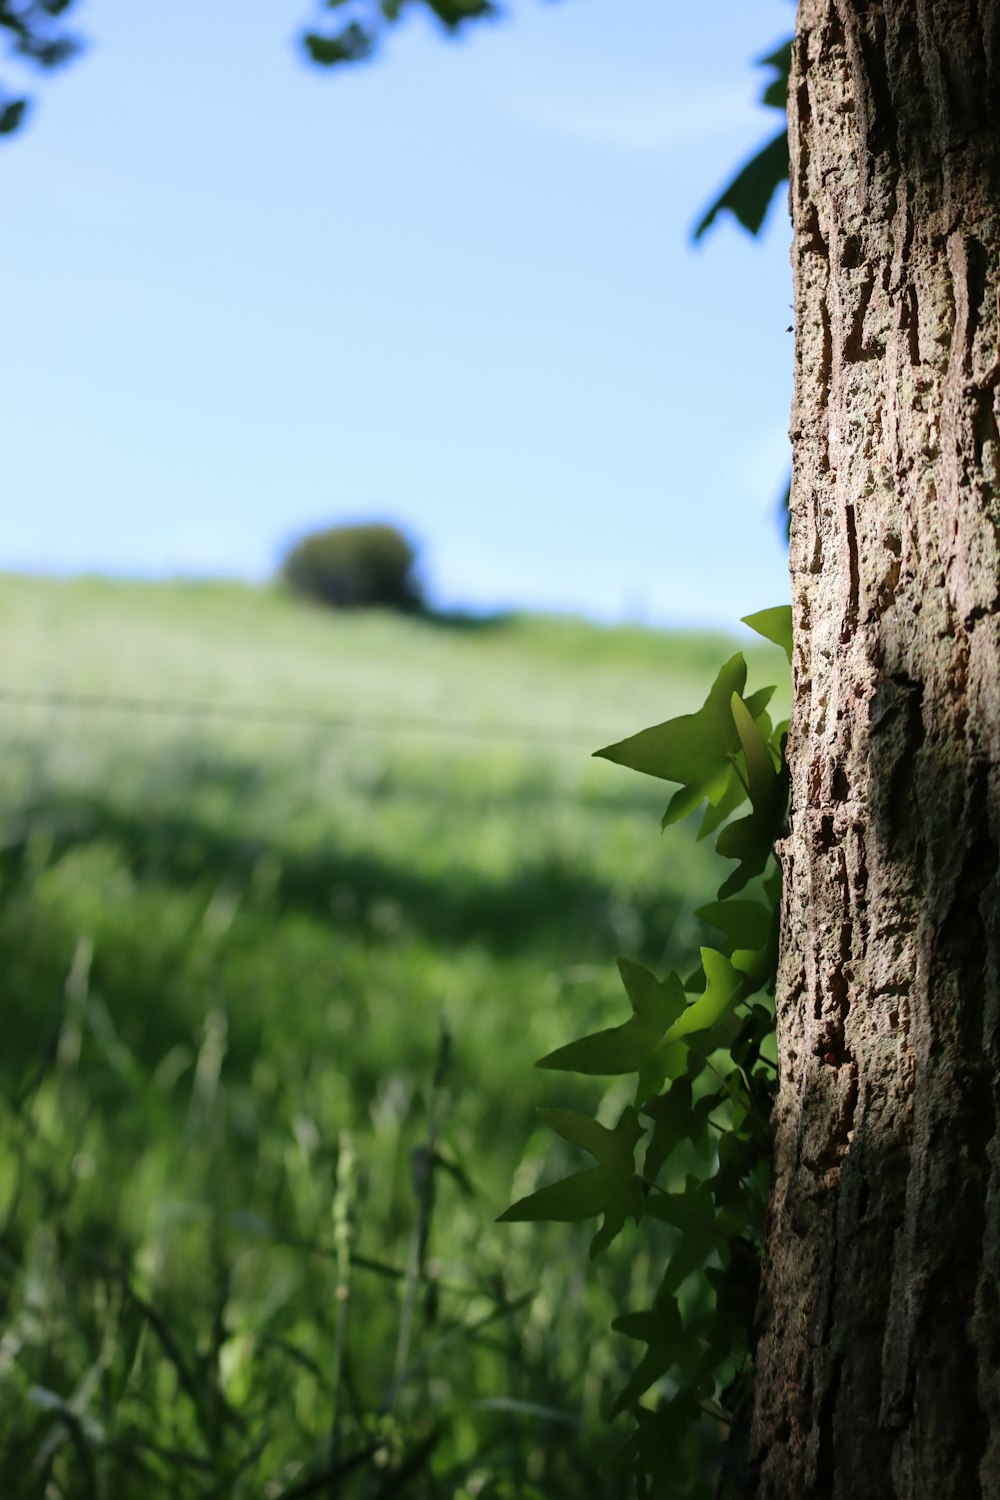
[282,522,421,611]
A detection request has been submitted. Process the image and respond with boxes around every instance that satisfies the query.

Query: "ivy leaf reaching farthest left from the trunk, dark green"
[498,1106,645,1260]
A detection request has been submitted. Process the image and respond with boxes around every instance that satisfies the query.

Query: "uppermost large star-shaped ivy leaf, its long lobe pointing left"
[594,654,747,825]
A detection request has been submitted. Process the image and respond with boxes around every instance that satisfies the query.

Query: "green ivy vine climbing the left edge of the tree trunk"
[502,608,792,1497]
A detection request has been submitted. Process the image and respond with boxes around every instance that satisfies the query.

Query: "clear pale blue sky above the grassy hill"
[0,0,793,624]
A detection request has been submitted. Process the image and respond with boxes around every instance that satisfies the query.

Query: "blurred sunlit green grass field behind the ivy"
[0,576,780,1500]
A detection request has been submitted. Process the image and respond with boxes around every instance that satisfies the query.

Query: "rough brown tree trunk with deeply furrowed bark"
[753,0,1000,1500]
